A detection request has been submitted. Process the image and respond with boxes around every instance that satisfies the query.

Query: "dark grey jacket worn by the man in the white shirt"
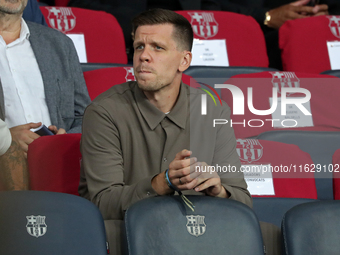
[0,22,91,133]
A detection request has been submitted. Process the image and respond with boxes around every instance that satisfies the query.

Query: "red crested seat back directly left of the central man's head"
[40,6,127,64]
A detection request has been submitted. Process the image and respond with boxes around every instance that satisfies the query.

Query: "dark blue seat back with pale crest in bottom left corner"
[0,191,107,255]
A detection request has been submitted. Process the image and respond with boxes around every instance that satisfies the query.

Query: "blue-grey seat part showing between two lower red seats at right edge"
[258,130,340,199]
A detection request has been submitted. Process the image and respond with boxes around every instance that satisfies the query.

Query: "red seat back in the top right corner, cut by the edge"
[279,15,340,73]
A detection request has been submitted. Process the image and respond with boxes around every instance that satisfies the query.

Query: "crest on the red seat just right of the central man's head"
[188,12,218,39]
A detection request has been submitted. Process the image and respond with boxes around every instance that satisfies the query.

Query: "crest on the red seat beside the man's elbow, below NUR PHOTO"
[236,139,263,163]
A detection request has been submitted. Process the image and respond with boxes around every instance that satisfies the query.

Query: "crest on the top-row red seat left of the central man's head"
[46,7,76,33]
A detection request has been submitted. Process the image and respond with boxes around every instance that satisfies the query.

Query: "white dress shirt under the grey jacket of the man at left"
[0,19,51,128]
